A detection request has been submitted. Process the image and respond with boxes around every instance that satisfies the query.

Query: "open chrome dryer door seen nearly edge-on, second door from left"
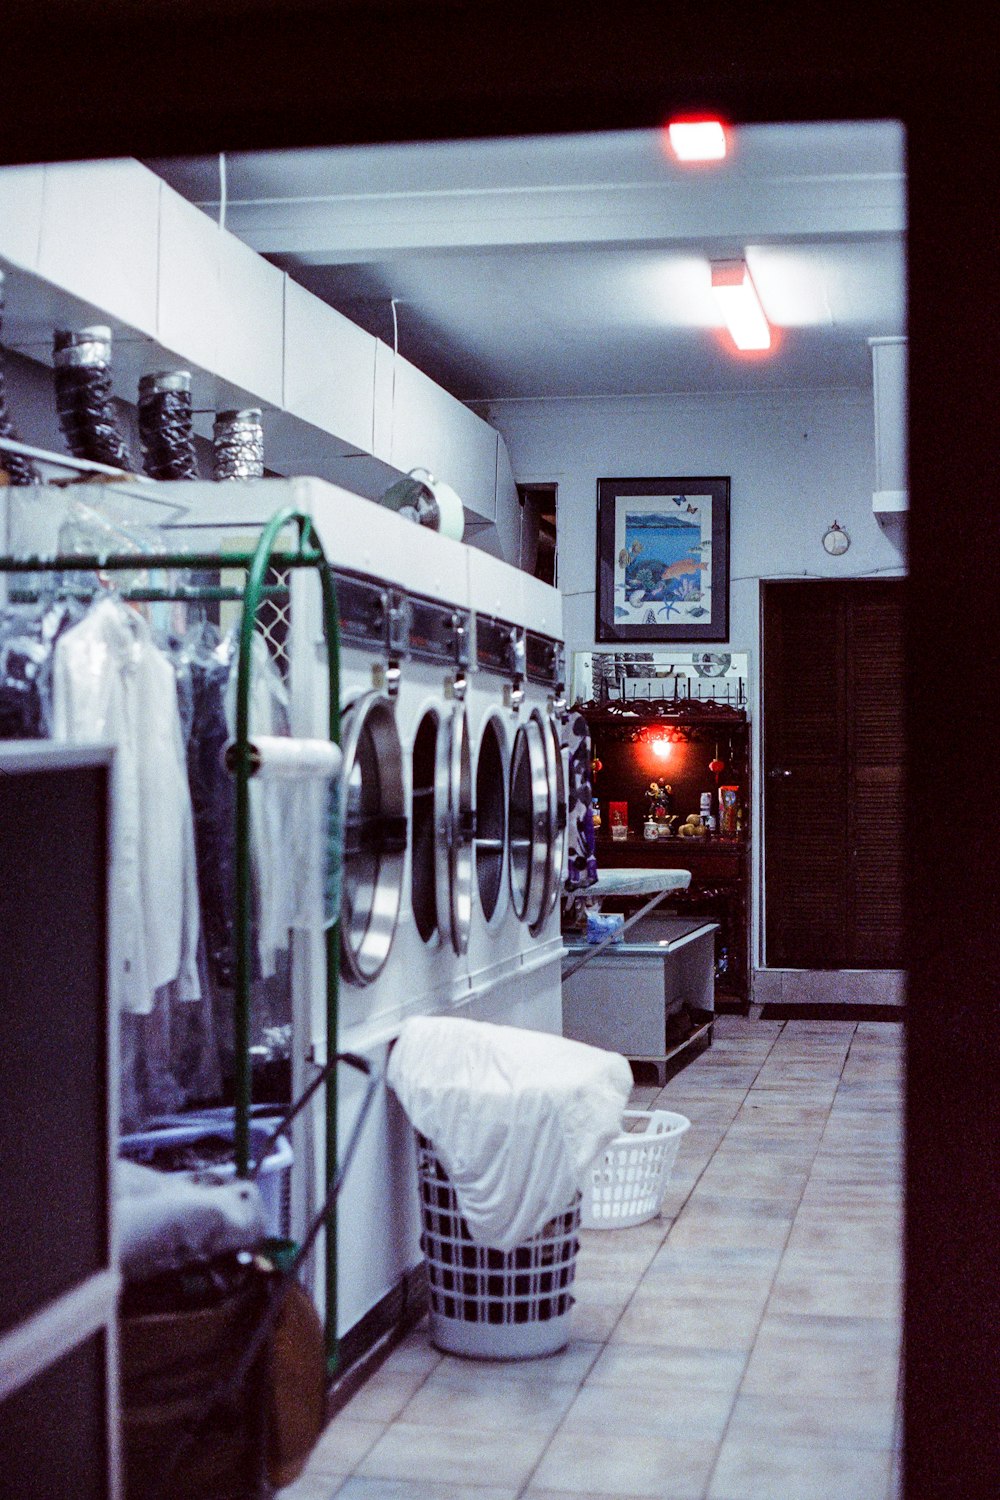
[435,707,475,954]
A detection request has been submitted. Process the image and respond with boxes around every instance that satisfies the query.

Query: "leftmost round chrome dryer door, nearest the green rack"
[340,693,406,984]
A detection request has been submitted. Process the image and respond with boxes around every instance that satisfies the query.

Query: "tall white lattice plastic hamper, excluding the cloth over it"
[417,1134,580,1359]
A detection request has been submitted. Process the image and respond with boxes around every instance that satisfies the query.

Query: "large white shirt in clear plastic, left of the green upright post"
[52,596,201,1014]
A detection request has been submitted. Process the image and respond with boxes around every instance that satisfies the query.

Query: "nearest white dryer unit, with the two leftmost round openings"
[301,486,474,1047]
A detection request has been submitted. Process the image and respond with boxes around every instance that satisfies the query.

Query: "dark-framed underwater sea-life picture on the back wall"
[595,477,729,641]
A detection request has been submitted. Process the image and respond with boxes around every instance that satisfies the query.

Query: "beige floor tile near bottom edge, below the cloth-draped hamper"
[357,1422,549,1490]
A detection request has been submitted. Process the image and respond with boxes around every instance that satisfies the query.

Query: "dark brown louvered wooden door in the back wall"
[762,579,904,969]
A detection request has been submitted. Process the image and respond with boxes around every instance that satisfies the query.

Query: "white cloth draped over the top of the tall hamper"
[387,1016,633,1250]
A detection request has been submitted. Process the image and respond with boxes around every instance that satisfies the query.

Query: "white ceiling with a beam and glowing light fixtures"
[150,122,906,402]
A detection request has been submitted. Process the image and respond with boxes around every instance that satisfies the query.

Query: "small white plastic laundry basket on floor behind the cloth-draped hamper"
[582,1110,691,1229]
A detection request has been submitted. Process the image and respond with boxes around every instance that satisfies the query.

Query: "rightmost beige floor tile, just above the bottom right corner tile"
[726,1391,895,1451]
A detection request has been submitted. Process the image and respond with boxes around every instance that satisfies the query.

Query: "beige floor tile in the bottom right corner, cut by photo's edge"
[708,1437,891,1500]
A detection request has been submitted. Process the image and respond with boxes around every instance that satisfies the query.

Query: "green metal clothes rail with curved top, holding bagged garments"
[0,506,352,1374]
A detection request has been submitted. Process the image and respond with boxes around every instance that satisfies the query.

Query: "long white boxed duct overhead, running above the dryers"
[0,159,514,548]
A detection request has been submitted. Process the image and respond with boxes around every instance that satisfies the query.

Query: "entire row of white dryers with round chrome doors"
[301,486,565,1047]
